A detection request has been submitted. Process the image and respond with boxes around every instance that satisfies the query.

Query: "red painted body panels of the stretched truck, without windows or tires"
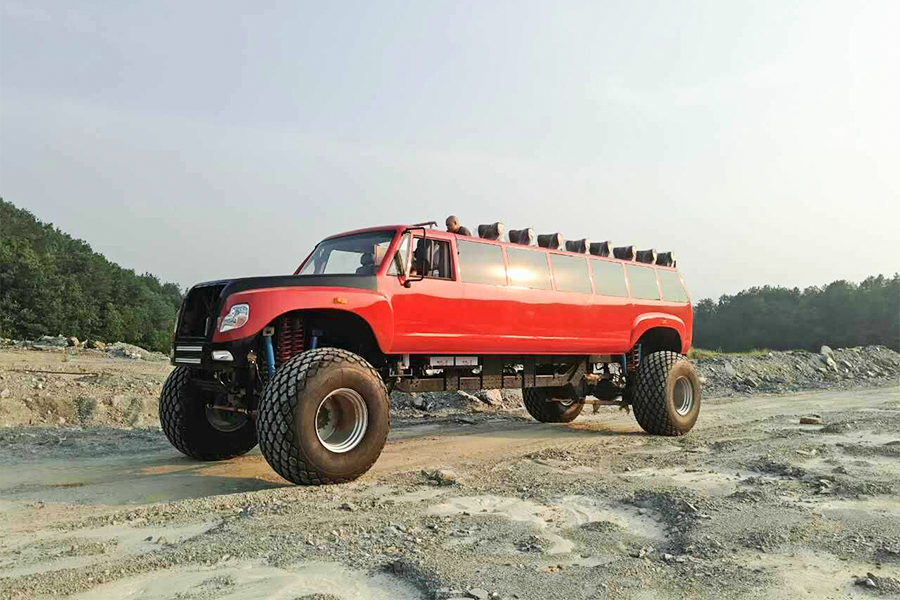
[211,225,692,355]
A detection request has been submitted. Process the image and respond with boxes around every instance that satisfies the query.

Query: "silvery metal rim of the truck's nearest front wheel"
[316,388,369,454]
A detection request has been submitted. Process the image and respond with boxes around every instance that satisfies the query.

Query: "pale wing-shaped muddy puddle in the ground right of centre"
[428,496,666,554]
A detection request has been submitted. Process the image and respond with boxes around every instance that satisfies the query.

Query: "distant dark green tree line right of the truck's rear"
[694,274,900,352]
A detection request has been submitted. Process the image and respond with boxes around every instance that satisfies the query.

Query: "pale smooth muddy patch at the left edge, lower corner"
[0,520,221,578]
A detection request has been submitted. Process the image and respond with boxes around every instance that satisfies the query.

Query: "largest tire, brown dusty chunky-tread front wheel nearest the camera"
[256,348,391,485]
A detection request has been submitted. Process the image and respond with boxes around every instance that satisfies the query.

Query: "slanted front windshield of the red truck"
[300,231,395,275]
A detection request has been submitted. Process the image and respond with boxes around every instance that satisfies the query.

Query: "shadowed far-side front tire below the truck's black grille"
[159,367,256,460]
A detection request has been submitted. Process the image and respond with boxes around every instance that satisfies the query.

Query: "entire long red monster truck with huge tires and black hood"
[159,224,700,484]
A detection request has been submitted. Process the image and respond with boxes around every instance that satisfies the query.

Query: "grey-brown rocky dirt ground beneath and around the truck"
[0,353,900,600]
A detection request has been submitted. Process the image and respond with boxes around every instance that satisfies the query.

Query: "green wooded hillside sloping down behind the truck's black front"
[0,198,181,353]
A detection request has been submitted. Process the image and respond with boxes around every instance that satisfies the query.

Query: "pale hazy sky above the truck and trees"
[0,0,900,300]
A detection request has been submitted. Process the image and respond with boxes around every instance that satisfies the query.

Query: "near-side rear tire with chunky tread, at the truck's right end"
[632,350,700,435]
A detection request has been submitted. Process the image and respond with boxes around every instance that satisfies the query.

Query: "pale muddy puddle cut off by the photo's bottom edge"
[71,563,424,600]
